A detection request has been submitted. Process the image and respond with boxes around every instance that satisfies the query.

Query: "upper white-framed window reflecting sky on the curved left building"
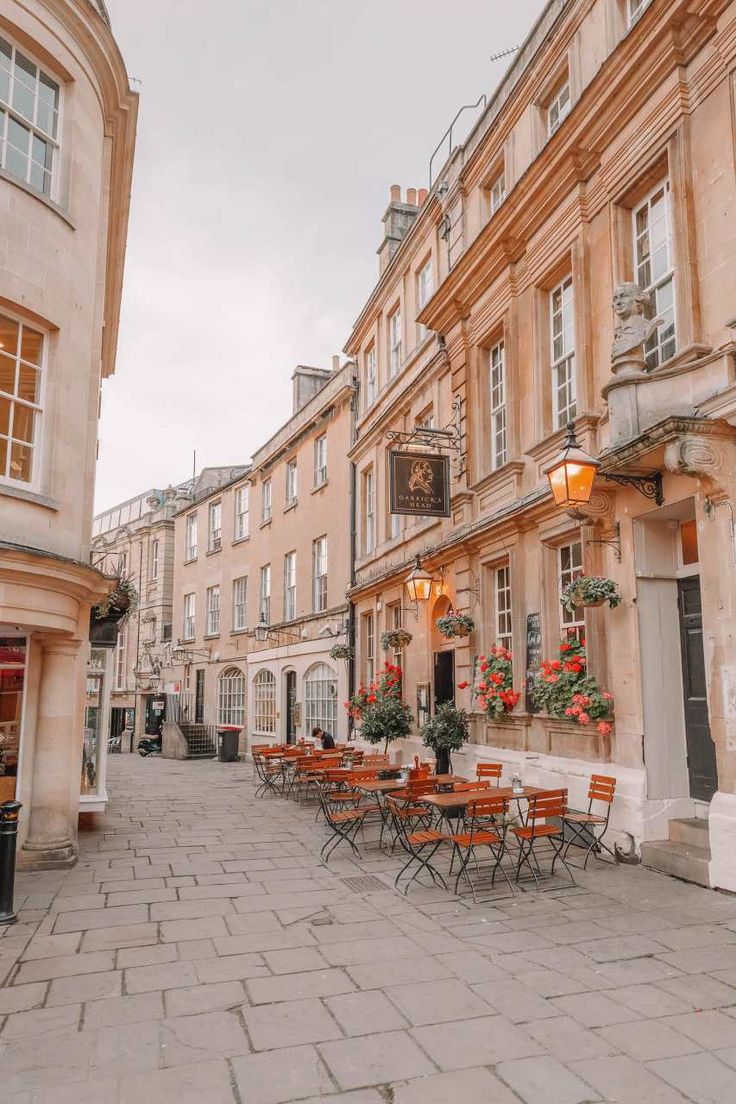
[0,38,60,198]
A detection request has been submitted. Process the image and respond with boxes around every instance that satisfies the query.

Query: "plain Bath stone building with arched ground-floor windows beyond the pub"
[163,358,354,754]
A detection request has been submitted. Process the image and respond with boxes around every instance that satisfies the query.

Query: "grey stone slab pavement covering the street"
[0,756,736,1104]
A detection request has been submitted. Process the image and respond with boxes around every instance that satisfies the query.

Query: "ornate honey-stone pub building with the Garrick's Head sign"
[345,0,736,890]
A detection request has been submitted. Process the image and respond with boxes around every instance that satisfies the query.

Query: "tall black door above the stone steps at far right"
[678,575,718,802]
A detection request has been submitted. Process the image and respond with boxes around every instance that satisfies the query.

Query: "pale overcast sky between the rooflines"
[97,0,544,510]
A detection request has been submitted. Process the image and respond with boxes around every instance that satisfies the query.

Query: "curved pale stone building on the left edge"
[0,0,137,867]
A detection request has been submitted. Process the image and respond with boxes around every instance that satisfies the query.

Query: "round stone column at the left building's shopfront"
[21,637,82,870]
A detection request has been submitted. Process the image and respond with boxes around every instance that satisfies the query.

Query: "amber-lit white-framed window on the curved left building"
[0,311,44,485]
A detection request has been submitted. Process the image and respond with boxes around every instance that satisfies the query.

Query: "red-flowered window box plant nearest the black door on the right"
[532,638,614,736]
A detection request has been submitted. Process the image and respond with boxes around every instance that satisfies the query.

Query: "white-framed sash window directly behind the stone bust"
[633,180,676,370]
